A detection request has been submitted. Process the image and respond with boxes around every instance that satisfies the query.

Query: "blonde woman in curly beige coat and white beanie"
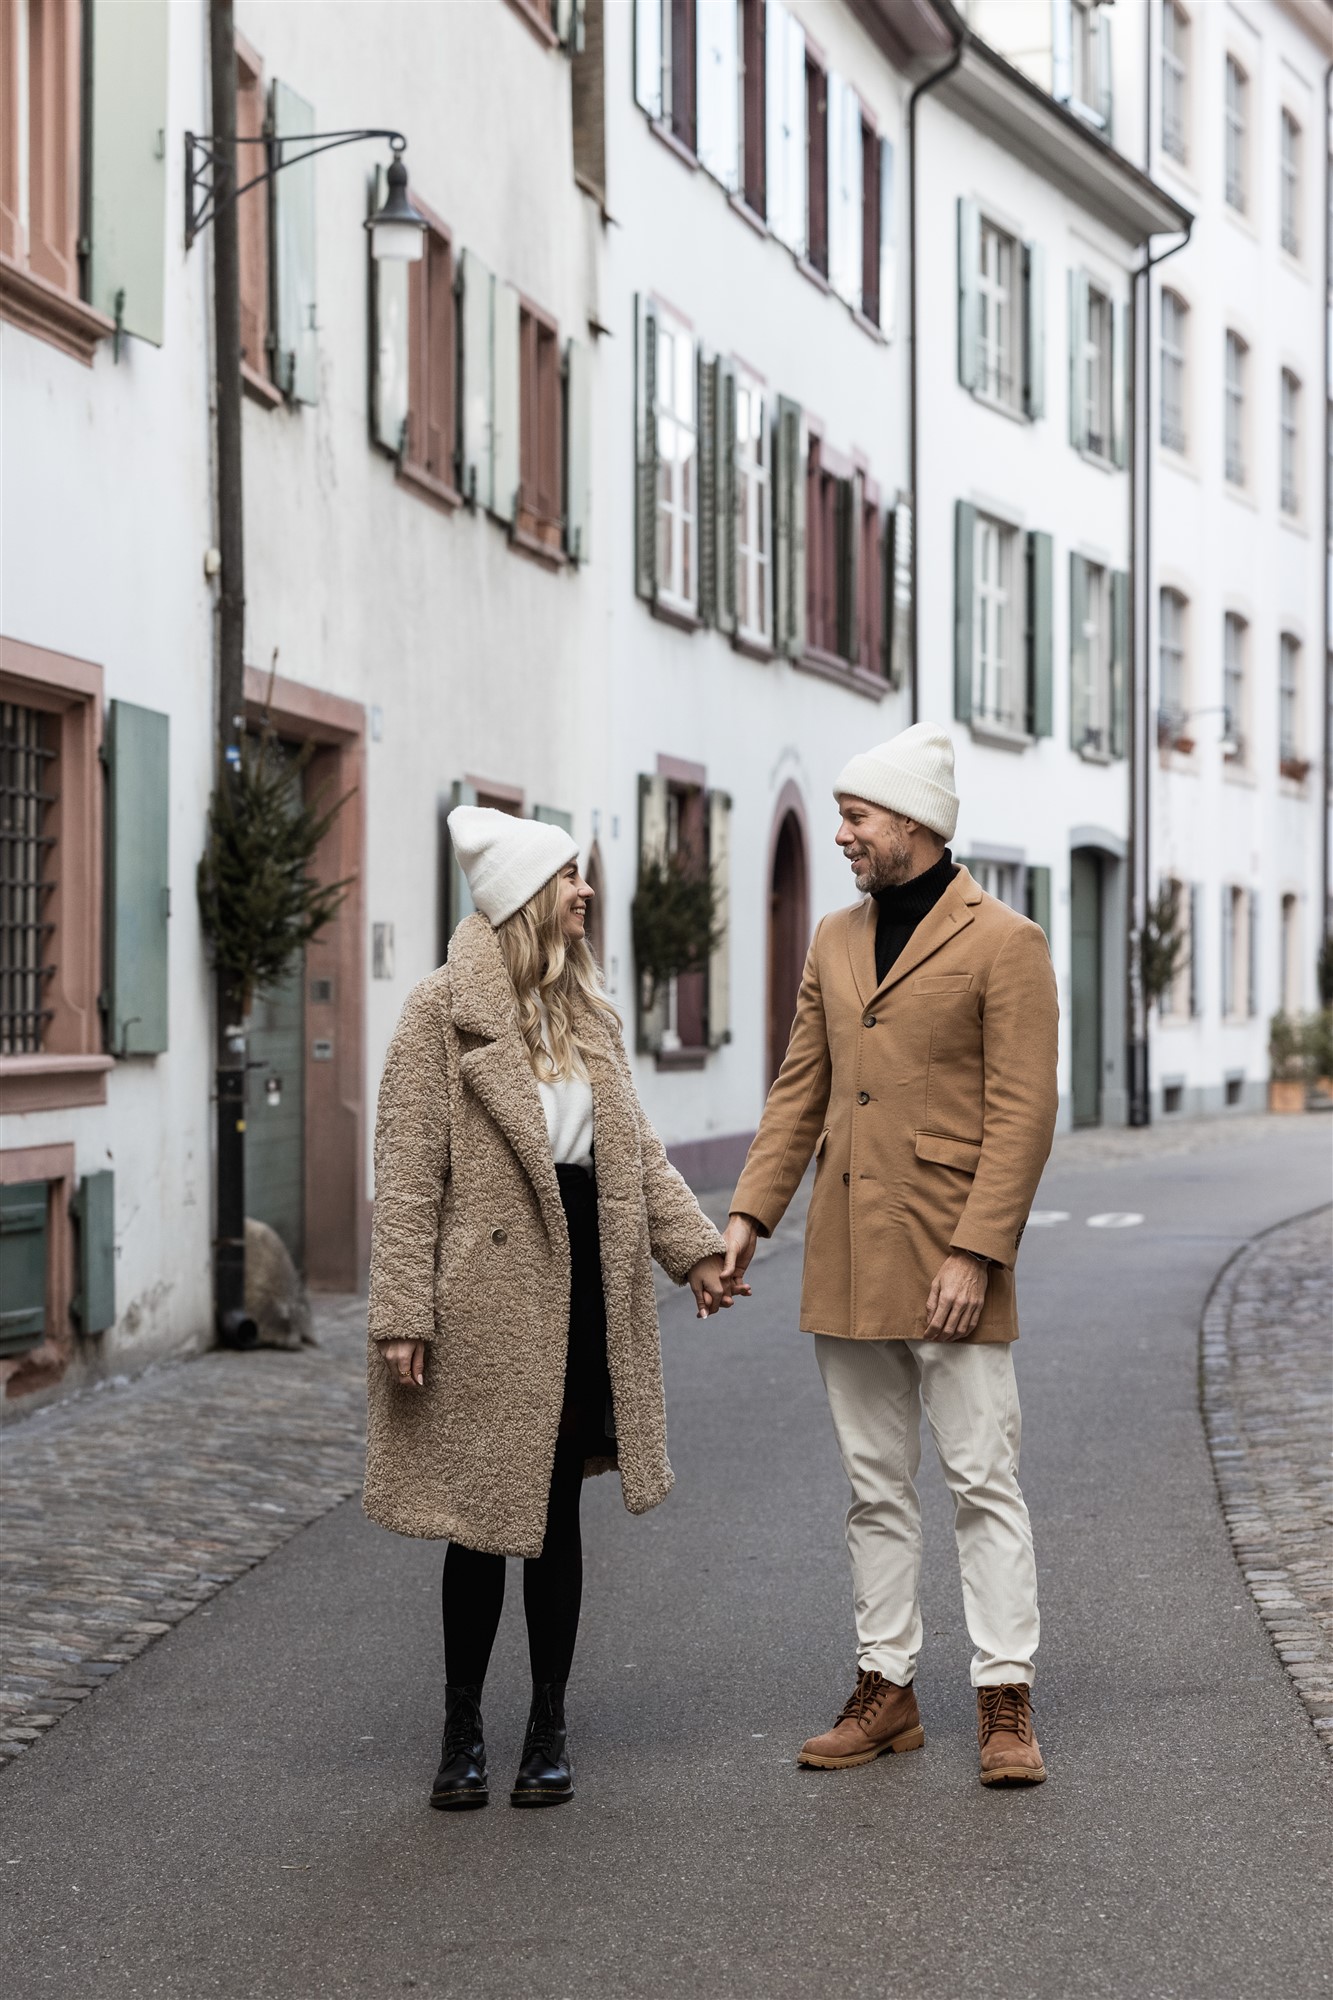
[366,806,731,1810]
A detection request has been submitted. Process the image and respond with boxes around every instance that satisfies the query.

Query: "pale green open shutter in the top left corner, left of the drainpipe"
[84,0,167,348]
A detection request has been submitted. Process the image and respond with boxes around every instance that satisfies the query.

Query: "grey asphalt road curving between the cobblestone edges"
[0,1118,1333,2000]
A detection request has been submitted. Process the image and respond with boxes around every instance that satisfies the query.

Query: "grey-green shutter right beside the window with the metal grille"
[106,702,170,1056]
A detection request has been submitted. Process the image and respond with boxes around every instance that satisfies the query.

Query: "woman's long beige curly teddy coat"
[364,916,723,1556]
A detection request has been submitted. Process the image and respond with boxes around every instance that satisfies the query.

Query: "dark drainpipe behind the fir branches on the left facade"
[208,0,256,1346]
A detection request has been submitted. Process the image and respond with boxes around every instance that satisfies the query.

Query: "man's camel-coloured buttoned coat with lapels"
[731,868,1059,1340]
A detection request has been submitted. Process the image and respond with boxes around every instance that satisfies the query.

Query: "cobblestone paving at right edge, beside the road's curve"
[1201,1208,1333,1752]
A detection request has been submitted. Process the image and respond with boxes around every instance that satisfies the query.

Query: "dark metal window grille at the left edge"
[0,702,56,1056]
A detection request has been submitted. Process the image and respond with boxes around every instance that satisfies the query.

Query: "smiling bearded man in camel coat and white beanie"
[723,722,1057,1784]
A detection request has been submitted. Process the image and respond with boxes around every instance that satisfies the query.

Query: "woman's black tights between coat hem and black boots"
[440,1440,586,1688]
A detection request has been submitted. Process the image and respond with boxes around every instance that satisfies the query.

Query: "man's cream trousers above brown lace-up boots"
[815,1334,1041,1688]
